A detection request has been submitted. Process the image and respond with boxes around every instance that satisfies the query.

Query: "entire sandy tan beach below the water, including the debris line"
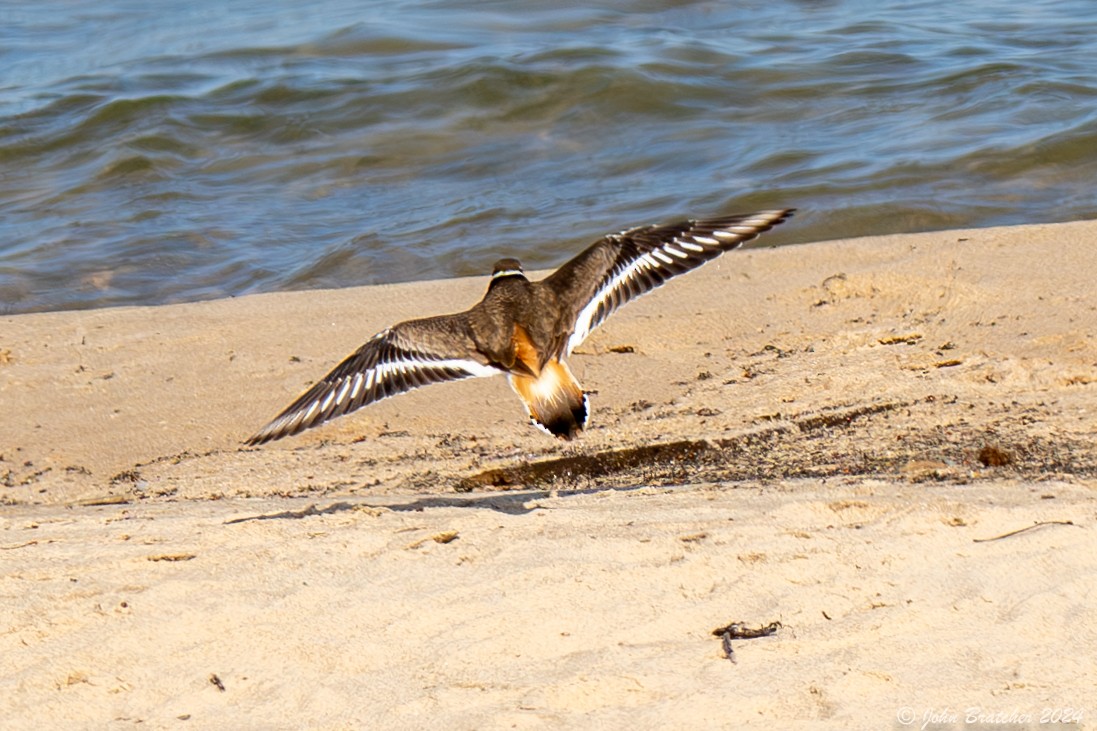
[0,222,1097,730]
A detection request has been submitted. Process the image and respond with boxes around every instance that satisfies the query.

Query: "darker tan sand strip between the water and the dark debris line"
[0,216,1097,504]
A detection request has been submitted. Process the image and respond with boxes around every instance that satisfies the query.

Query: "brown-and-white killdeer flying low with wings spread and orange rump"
[247,209,793,445]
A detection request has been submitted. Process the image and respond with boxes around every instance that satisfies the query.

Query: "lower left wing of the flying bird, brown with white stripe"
[247,313,506,445]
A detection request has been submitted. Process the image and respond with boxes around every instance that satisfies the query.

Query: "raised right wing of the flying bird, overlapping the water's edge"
[544,209,794,353]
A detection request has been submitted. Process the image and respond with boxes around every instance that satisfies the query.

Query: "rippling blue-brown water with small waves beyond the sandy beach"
[0,0,1097,314]
